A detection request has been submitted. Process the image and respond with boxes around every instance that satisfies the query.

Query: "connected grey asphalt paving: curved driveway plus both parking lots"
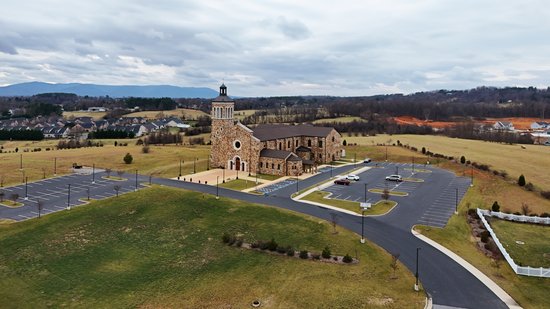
[0,163,507,308]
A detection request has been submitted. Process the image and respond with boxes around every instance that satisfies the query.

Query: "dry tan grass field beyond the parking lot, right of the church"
[350,135,550,190]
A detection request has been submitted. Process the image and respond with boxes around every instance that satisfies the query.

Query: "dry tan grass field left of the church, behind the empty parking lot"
[0,140,210,185]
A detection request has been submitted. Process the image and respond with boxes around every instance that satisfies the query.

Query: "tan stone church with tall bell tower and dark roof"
[210,84,343,176]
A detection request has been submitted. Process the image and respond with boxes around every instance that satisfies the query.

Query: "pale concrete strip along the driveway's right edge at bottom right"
[411,226,522,309]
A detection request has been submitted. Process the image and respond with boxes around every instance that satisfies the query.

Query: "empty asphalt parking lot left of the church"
[0,172,144,221]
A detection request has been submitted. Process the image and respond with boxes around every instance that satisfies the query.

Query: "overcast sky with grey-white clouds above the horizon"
[0,0,550,96]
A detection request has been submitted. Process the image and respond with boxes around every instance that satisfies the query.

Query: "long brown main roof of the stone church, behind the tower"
[252,124,333,141]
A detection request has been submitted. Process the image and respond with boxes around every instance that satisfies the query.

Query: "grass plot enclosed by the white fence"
[490,218,550,268]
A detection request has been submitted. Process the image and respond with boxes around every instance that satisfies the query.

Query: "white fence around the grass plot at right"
[477,208,550,278]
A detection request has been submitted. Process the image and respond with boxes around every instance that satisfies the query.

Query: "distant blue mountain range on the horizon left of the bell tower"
[0,82,218,99]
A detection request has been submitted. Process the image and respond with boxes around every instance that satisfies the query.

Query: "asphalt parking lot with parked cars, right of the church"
[323,162,470,227]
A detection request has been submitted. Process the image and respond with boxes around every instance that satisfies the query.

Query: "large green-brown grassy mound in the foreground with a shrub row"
[0,187,424,308]
